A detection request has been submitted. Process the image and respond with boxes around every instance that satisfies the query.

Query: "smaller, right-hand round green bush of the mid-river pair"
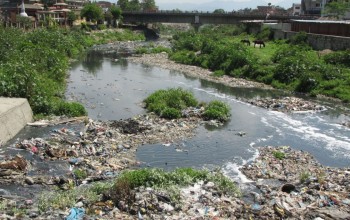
[203,101,230,122]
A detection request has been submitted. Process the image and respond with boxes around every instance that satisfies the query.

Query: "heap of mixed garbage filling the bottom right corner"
[241,147,350,219]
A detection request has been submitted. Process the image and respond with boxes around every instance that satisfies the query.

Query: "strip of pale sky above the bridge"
[155,0,301,11]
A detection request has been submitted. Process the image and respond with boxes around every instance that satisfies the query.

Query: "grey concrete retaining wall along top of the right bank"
[274,30,350,51]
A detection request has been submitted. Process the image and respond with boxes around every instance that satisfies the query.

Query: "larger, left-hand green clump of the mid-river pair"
[144,88,198,119]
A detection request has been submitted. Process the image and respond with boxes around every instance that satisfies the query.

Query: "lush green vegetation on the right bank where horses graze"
[169,26,350,102]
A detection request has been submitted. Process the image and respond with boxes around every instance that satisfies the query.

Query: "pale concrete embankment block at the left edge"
[0,97,33,144]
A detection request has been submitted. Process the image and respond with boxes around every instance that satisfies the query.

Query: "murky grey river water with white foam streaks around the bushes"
[66,52,350,181]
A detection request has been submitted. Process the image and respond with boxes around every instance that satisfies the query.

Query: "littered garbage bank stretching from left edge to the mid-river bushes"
[0,114,201,188]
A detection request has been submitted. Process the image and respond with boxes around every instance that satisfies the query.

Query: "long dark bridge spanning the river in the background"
[122,11,315,25]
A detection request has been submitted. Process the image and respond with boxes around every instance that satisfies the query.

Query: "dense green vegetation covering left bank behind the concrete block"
[0,27,144,117]
